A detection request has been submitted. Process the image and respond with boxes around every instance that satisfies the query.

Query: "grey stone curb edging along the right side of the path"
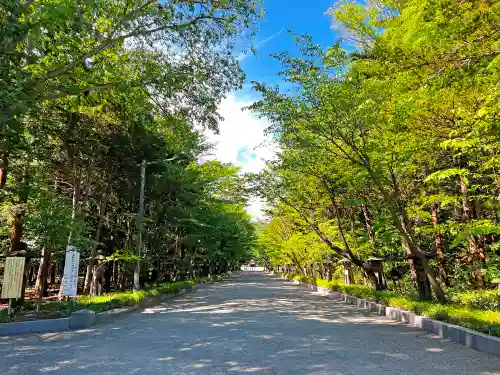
[280,276,500,357]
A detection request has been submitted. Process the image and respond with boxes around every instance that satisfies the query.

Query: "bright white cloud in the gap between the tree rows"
[205,94,277,219]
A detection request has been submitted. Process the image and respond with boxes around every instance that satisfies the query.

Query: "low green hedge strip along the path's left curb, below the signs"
[0,275,224,324]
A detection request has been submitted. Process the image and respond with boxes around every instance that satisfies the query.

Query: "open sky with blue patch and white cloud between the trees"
[207,0,342,218]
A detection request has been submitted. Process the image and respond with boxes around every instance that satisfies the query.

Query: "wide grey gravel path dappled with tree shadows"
[0,273,500,375]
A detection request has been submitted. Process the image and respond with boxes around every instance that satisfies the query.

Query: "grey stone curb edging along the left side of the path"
[0,278,225,335]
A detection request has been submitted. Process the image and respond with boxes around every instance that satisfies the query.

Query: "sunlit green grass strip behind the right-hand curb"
[285,275,500,337]
